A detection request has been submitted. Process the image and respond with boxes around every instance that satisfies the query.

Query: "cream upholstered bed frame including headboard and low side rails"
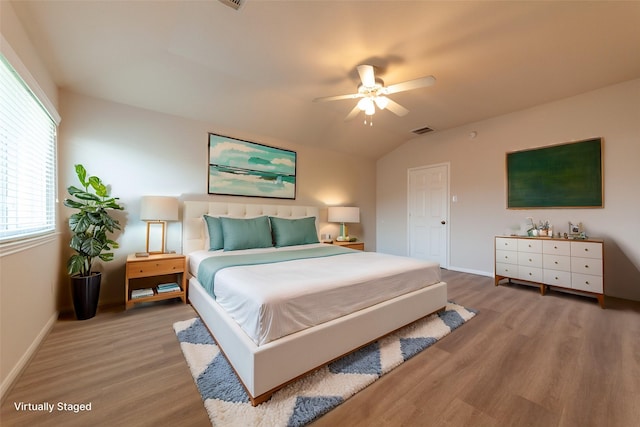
[182,201,447,406]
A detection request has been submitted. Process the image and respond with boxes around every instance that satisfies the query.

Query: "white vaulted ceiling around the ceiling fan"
[8,0,640,159]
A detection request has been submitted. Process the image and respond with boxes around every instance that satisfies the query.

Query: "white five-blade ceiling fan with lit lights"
[313,65,436,124]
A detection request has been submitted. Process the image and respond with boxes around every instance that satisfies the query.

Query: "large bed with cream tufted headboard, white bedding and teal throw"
[182,201,447,405]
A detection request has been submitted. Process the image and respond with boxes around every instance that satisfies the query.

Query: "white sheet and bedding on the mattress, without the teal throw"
[189,244,440,345]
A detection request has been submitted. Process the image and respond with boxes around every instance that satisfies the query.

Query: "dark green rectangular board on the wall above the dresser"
[506,138,604,209]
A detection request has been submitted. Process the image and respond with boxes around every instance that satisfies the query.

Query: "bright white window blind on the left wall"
[0,55,56,242]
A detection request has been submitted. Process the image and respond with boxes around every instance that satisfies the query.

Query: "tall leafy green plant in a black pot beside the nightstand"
[64,165,124,320]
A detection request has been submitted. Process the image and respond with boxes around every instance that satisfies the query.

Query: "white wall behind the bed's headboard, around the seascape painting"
[58,91,376,307]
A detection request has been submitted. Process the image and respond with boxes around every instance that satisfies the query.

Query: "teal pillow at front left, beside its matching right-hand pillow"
[220,216,273,251]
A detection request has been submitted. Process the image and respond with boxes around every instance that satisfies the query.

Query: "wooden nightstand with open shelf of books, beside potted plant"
[124,254,187,310]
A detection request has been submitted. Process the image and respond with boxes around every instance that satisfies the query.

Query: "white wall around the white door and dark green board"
[376,80,640,300]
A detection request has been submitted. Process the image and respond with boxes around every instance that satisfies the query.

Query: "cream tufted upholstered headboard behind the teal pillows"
[182,201,320,254]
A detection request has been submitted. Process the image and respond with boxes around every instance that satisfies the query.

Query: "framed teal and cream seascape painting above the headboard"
[209,133,297,199]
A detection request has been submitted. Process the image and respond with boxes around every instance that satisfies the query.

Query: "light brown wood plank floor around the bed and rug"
[0,271,640,427]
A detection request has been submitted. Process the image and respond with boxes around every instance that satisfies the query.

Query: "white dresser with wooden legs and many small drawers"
[495,236,604,308]
